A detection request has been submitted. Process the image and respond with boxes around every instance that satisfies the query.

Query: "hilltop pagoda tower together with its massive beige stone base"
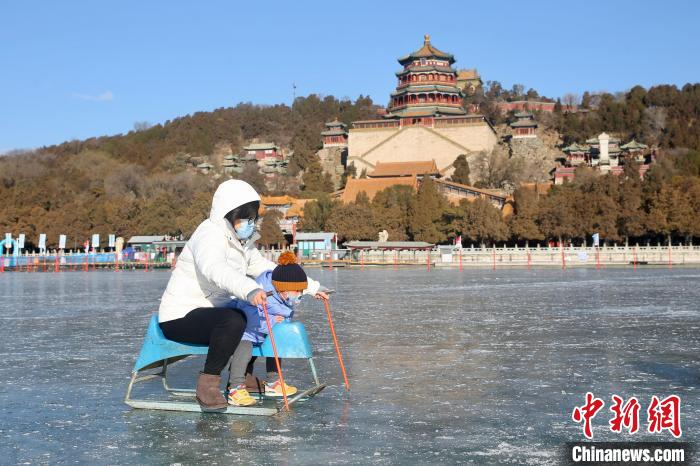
[344,35,498,176]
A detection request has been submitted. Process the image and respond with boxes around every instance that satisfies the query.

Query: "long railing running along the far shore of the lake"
[0,245,700,273]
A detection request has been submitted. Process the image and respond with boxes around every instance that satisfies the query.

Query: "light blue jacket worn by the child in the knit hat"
[231,270,294,344]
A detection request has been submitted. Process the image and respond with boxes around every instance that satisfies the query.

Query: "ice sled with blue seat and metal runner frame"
[124,314,326,416]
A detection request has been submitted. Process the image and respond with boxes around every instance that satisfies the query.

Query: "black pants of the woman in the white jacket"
[160,307,246,375]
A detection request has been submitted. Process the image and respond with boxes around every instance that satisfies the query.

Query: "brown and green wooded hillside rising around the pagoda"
[0,84,700,251]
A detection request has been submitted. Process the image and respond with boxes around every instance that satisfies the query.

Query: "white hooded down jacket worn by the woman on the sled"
[158,180,319,322]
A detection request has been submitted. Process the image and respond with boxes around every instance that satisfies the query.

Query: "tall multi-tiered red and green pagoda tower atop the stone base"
[387,34,467,123]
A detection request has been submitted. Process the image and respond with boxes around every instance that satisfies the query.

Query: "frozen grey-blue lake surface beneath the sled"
[0,268,700,464]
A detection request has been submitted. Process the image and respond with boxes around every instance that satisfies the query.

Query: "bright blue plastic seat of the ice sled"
[134,314,312,372]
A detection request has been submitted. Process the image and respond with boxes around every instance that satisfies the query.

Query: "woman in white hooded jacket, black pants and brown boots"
[158,180,323,410]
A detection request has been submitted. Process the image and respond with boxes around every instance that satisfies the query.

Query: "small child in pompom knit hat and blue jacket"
[227,251,318,406]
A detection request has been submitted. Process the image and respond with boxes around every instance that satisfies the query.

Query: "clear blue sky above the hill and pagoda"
[0,0,700,153]
